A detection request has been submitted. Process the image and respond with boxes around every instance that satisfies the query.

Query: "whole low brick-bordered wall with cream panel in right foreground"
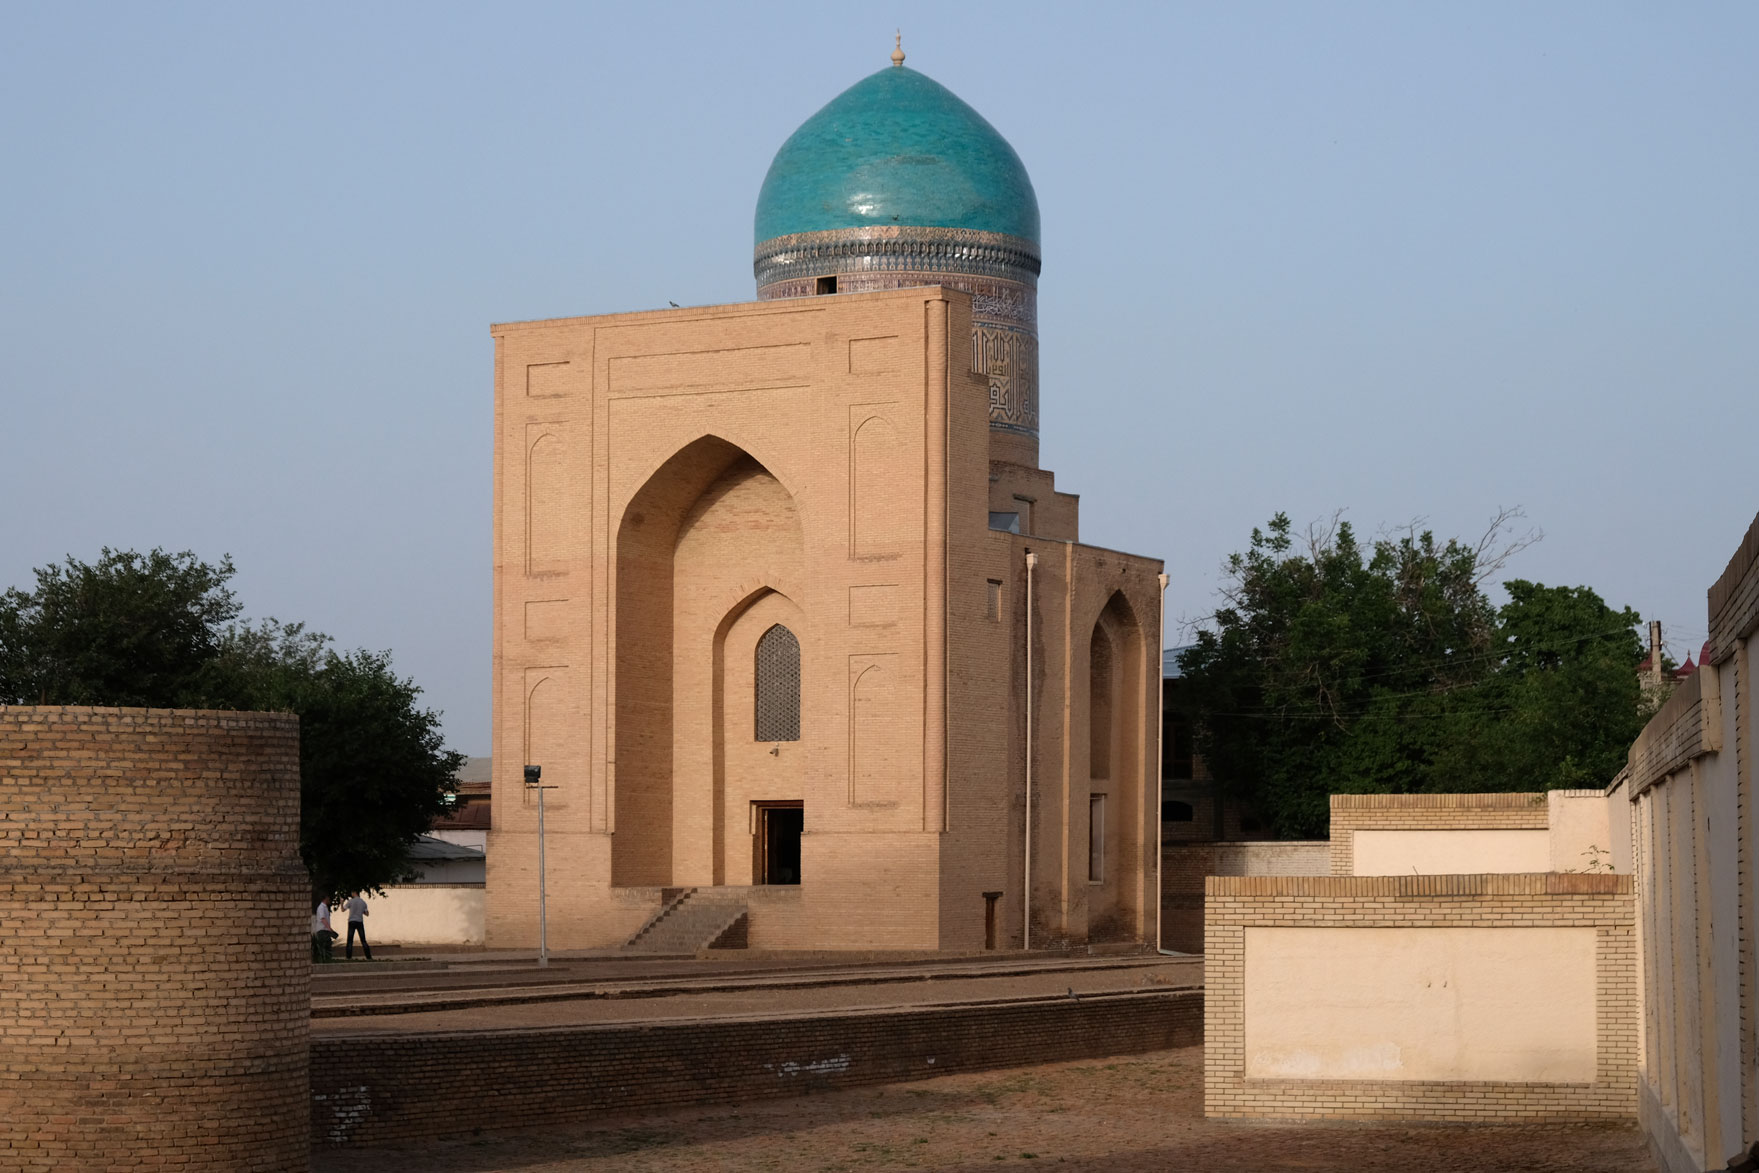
[1203,872,1638,1122]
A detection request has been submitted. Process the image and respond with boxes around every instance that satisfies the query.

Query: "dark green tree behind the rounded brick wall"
[0,549,464,893]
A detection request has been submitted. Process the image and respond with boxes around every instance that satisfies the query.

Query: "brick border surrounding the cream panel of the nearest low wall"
[1203,874,1638,1122]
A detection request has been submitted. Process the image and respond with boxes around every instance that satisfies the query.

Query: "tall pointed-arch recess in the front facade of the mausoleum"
[610,436,811,886]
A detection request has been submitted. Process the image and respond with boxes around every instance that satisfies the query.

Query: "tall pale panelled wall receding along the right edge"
[1611,519,1759,1173]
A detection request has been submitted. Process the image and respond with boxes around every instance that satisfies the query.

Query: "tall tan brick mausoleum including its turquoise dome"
[487,55,1161,950]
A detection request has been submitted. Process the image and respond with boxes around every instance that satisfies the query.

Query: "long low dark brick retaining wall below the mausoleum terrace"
[311,990,1203,1147]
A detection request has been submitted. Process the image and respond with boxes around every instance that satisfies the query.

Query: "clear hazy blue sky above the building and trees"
[0,0,1759,753]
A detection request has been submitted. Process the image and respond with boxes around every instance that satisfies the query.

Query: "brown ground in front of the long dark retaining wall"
[311,1046,1655,1173]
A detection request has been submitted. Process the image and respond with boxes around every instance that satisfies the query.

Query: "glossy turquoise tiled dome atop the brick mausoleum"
[756,65,1038,244]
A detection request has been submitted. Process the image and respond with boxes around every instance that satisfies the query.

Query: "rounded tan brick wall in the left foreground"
[0,707,311,1171]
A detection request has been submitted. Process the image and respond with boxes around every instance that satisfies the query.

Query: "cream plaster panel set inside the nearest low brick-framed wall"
[1245,928,1595,1083]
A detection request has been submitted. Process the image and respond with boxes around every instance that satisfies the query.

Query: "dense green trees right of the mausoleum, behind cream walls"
[1177,512,1645,837]
